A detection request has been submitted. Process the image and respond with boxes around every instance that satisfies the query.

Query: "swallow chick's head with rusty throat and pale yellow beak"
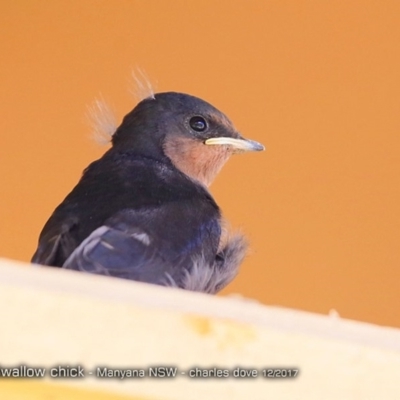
[112,92,264,186]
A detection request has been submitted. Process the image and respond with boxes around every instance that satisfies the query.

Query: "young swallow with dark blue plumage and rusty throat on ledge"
[32,92,264,294]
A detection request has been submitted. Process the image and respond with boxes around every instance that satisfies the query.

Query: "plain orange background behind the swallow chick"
[0,0,400,327]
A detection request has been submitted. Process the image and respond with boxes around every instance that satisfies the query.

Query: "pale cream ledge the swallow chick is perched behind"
[0,259,400,400]
